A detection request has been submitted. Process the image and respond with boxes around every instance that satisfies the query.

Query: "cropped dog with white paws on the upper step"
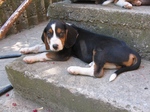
[95,0,150,9]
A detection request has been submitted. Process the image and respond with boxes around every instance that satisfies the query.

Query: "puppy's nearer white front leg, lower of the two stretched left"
[23,53,51,64]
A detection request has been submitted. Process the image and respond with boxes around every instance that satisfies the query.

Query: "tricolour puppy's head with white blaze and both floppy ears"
[42,21,78,51]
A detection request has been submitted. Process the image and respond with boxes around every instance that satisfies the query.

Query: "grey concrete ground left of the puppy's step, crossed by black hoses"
[0,21,53,112]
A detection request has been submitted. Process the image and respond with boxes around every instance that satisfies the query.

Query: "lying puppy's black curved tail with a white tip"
[109,53,141,82]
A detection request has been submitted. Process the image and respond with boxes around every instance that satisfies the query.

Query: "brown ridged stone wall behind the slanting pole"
[0,0,60,35]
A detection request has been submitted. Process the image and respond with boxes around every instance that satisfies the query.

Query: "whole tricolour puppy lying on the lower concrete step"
[20,21,141,81]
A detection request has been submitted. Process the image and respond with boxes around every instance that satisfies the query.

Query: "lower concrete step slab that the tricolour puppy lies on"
[6,57,150,112]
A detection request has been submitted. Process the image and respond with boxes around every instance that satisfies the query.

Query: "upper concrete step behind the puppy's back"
[48,1,150,60]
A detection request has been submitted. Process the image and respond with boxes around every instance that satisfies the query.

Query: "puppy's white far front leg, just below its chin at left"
[20,44,46,54]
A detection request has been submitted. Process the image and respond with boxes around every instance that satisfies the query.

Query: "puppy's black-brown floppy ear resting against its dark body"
[65,24,78,48]
